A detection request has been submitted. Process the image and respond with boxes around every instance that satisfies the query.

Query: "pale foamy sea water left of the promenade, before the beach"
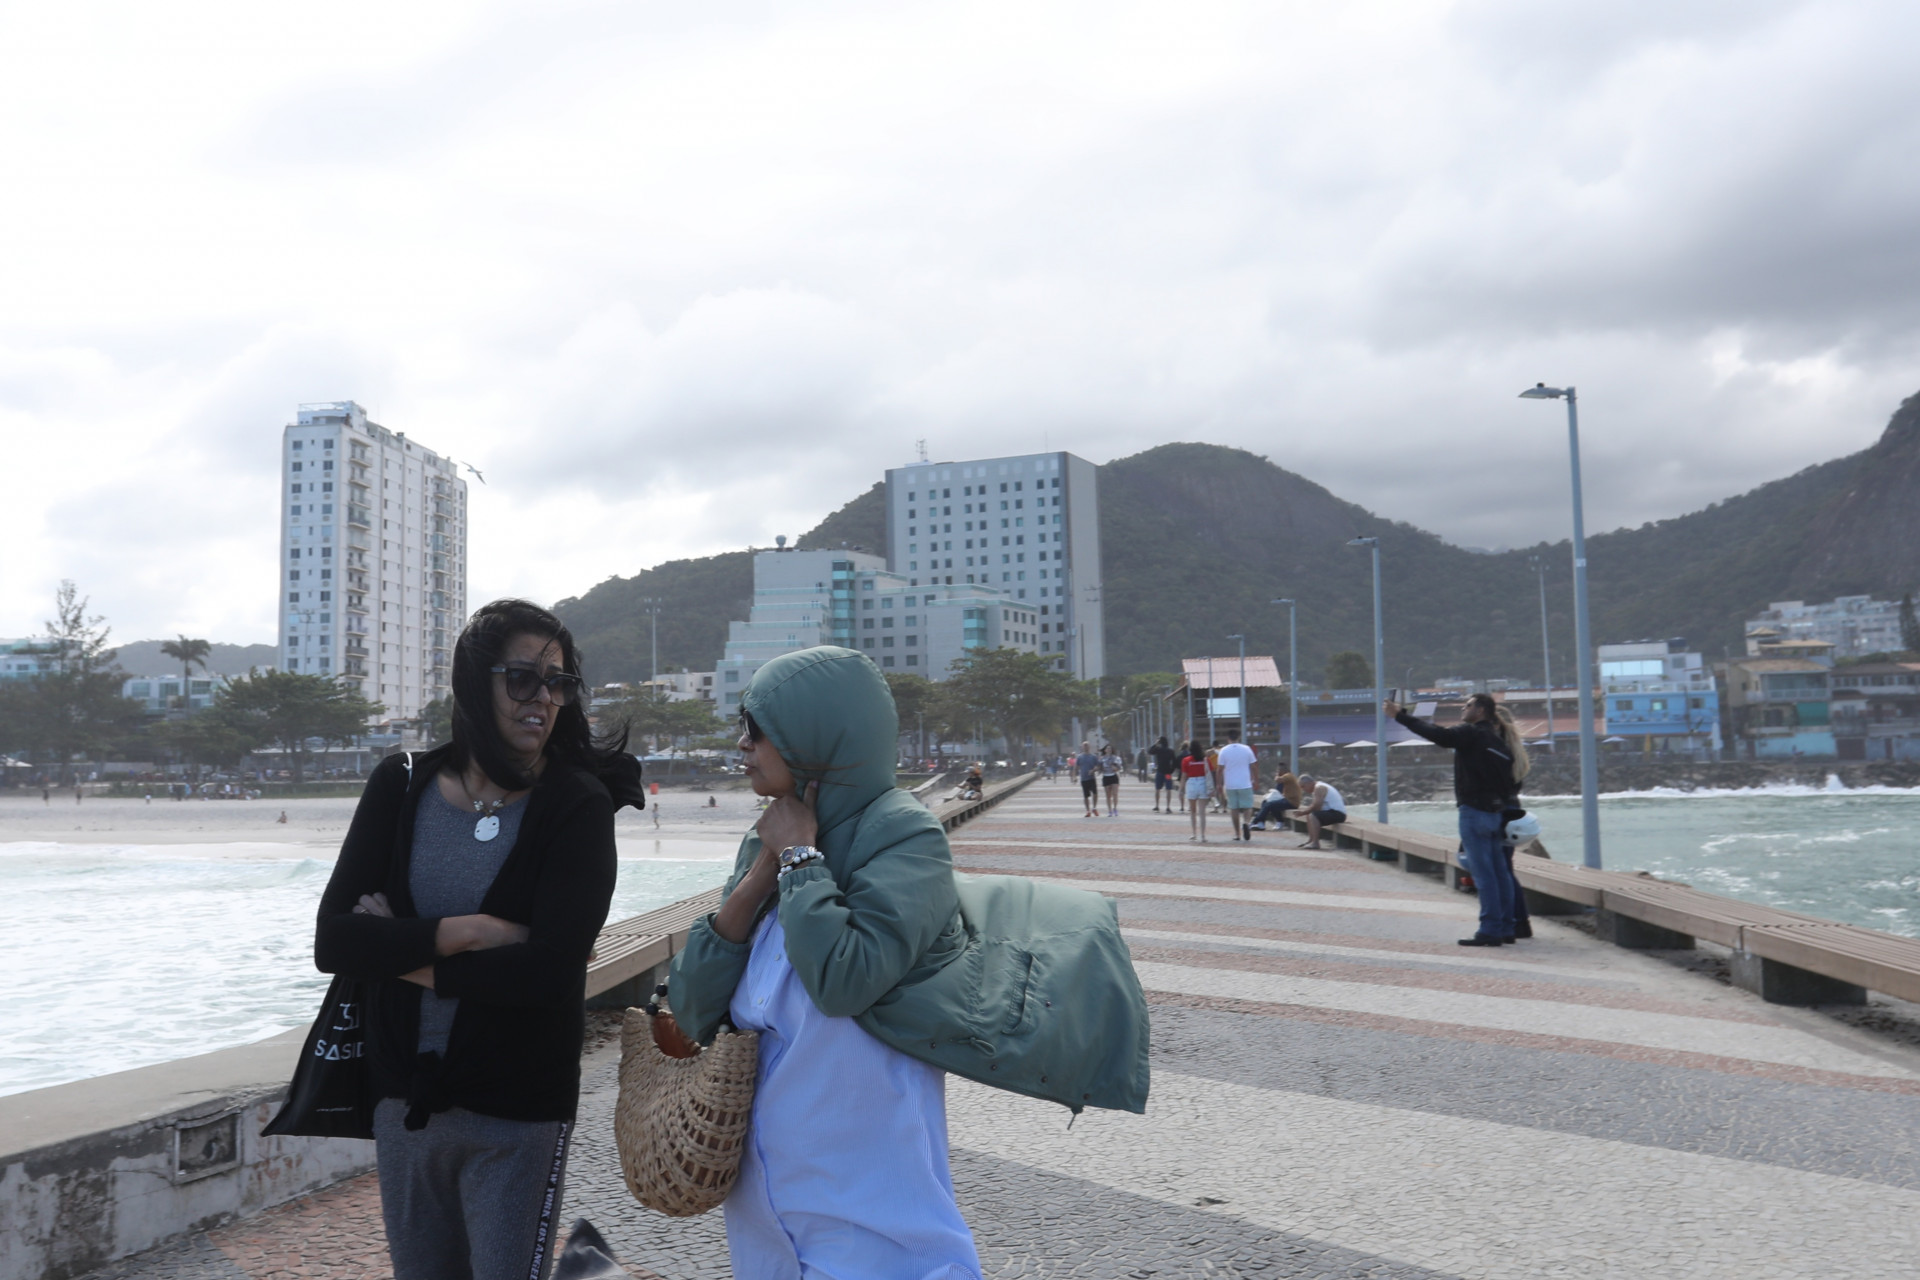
[0,839,733,1094]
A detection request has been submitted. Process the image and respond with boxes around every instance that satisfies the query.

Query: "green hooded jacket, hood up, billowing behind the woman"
[668,645,1148,1111]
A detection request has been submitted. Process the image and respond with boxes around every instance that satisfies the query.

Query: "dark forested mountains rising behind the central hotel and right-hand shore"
[555,395,1920,685]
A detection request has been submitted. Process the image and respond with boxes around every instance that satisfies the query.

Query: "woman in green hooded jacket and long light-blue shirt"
[668,645,1148,1280]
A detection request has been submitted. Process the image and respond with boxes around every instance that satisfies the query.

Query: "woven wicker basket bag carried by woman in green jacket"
[612,986,760,1219]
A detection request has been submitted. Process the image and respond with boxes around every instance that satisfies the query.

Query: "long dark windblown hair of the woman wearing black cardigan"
[447,601,626,791]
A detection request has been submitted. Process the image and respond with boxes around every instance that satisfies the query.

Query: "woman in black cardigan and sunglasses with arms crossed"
[313,601,645,1280]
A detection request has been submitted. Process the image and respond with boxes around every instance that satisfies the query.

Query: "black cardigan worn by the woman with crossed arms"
[313,747,625,1128]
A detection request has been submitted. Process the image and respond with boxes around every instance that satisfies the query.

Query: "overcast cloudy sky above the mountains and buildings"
[0,0,1920,641]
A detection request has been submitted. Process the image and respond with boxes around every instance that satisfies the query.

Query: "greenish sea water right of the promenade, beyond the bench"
[1390,781,1920,936]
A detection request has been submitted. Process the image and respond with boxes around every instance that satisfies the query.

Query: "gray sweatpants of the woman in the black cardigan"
[372,1098,574,1280]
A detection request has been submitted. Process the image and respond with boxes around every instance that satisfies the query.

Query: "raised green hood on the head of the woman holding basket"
[741,645,900,856]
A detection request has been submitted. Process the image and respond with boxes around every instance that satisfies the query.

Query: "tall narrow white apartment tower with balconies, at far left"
[278,399,467,720]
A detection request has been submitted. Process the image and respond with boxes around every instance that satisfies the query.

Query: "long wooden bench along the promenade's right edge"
[1288,818,1920,1004]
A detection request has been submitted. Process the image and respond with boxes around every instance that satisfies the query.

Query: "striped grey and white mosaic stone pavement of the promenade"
[96,783,1920,1280]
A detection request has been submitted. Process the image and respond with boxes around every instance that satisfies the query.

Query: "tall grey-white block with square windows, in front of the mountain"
[887,453,1106,679]
